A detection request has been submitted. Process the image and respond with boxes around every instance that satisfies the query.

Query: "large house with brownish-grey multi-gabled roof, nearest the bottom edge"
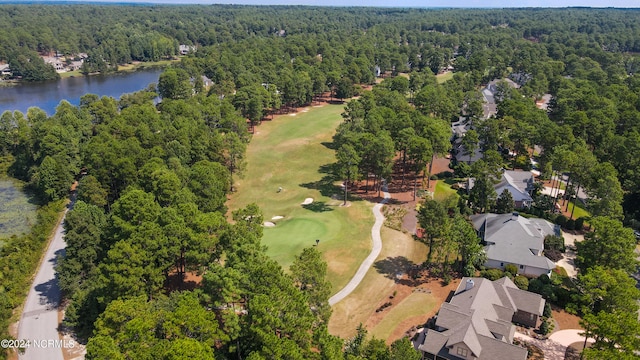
[418,277,545,360]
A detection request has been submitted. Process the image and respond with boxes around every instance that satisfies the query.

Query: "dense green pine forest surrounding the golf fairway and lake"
[0,5,640,360]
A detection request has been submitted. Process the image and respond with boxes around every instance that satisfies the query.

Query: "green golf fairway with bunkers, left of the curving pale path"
[228,105,374,293]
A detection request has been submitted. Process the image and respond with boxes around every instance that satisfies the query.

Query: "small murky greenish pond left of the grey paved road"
[0,179,36,245]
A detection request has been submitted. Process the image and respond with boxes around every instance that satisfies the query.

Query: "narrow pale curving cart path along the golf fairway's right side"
[329,184,391,306]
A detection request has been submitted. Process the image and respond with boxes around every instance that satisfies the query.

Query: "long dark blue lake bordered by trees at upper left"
[0,67,163,115]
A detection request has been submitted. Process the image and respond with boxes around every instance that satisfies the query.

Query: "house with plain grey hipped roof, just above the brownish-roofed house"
[471,212,561,276]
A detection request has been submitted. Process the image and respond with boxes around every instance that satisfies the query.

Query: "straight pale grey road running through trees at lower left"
[18,205,67,360]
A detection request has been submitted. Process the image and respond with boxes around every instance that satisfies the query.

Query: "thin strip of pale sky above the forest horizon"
[12,0,640,8]
